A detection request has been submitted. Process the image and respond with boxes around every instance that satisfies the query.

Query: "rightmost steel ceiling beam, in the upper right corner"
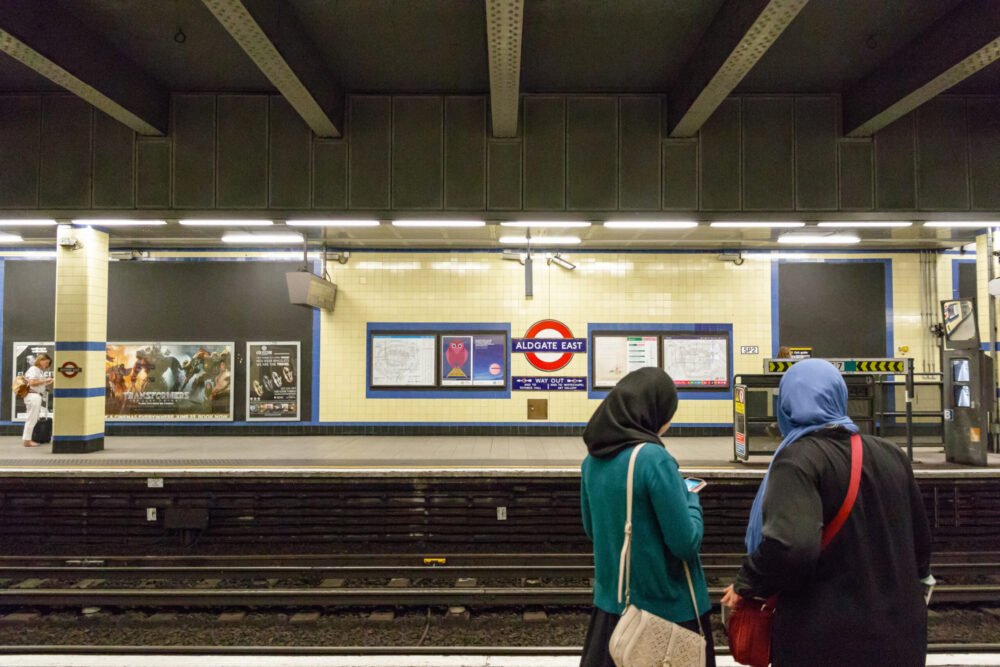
[843,0,1000,137]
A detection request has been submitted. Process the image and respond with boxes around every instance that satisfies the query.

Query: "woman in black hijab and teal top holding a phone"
[580,368,715,667]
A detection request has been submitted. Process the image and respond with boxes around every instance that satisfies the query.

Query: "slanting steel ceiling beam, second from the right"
[668,0,808,137]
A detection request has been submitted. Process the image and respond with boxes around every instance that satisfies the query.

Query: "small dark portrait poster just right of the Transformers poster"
[247,342,301,421]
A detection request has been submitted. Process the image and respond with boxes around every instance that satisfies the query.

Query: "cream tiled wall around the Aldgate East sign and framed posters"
[319,252,951,424]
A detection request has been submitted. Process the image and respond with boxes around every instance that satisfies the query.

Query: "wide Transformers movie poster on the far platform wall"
[104,343,234,421]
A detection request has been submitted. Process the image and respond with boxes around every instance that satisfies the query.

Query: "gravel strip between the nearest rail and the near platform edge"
[0,605,1000,646]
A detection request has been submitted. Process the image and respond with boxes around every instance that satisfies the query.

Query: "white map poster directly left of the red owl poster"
[371,334,436,387]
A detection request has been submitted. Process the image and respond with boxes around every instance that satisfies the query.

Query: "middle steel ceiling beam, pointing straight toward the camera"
[486,0,524,137]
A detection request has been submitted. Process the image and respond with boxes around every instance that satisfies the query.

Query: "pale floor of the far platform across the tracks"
[0,436,1000,474]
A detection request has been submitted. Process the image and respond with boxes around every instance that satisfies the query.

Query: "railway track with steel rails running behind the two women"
[0,552,1000,608]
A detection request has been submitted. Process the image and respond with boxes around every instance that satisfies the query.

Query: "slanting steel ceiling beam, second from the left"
[202,0,344,137]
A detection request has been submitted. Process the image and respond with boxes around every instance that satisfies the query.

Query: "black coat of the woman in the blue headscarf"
[736,430,930,667]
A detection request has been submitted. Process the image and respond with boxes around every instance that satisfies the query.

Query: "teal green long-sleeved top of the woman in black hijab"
[580,444,711,623]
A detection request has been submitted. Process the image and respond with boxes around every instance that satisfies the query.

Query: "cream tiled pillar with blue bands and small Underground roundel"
[52,225,108,454]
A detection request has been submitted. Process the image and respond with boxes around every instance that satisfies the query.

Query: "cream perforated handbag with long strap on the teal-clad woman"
[608,445,705,667]
